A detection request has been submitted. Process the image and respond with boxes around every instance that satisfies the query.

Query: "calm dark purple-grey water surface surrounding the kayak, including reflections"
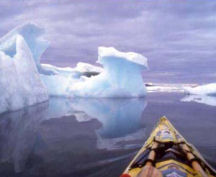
[0,93,216,177]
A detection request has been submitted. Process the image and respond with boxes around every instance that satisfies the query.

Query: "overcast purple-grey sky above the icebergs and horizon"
[0,0,216,83]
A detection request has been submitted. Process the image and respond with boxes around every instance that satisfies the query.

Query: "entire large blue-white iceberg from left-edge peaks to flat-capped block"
[0,23,148,113]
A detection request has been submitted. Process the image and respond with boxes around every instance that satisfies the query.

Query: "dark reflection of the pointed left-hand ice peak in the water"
[0,103,48,172]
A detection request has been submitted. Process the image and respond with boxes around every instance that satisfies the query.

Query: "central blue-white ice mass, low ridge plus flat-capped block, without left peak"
[41,47,148,97]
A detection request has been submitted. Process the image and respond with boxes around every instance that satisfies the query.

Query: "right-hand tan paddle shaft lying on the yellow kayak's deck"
[180,144,208,177]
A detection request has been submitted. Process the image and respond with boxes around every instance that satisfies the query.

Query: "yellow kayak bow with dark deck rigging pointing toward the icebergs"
[121,117,216,177]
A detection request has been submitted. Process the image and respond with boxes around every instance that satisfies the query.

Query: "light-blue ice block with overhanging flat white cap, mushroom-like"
[70,47,148,97]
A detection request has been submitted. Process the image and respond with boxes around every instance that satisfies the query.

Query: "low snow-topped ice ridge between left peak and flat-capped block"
[40,62,103,97]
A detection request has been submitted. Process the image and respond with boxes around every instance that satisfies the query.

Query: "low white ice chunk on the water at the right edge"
[185,83,216,95]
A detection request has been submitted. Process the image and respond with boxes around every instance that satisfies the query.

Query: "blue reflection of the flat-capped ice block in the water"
[72,98,147,149]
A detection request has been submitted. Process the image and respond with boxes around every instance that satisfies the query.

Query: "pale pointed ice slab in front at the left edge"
[0,34,48,113]
